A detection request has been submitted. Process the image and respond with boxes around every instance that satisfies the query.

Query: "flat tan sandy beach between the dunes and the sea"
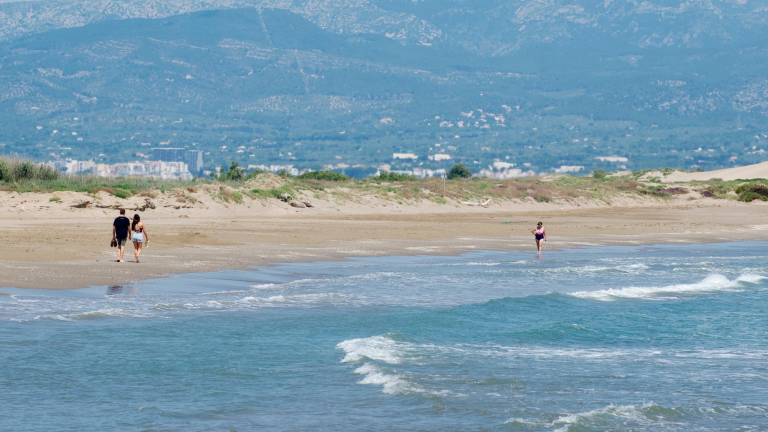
[0,187,768,289]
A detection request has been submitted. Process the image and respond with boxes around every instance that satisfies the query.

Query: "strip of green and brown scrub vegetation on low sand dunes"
[0,158,768,204]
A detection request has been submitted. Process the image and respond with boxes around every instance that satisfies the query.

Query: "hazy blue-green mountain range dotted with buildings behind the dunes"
[0,0,768,172]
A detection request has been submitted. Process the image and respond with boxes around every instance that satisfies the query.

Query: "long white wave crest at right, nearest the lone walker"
[569,274,765,301]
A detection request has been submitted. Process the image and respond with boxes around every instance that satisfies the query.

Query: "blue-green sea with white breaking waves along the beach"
[0,242,768,432]
